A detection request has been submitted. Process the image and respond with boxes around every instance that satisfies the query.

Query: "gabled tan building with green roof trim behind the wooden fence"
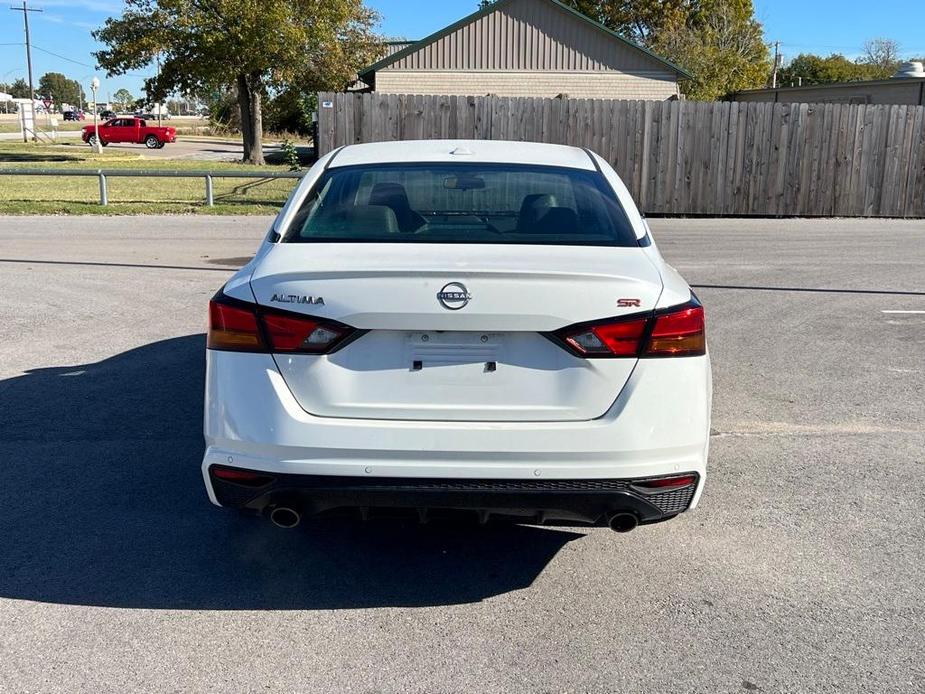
[359,0,690,100]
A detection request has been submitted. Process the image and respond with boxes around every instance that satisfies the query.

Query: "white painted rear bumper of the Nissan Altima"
[202,350,711,519]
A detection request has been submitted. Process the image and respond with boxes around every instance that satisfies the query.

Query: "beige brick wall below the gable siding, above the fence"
[376,69,678,101]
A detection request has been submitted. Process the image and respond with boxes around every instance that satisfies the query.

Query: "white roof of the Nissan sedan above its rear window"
[329,140,595,171]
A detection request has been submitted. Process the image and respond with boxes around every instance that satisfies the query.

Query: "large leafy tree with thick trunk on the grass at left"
[93,0,380,164]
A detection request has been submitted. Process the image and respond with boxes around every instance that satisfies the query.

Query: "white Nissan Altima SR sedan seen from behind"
[202,140,711,531]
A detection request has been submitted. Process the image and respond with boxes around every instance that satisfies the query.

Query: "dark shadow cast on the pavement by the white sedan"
[0,335,581,609]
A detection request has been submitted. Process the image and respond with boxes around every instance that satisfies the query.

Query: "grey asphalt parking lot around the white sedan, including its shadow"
[0,217,925,692]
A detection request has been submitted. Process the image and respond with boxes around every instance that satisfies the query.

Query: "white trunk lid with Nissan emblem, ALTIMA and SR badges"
[251,243,662,421]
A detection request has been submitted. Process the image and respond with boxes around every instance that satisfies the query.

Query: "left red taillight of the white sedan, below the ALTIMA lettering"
[206,298,356,354]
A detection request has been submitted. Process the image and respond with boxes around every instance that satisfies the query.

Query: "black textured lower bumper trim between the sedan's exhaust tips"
[208,466,700,525]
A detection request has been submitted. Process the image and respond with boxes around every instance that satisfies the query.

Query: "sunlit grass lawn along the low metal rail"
[0,142,298,214]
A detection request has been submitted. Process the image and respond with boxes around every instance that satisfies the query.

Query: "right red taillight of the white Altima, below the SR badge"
[554,300,707,358]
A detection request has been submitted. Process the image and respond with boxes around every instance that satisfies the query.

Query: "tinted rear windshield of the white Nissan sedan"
[283,163,638,246]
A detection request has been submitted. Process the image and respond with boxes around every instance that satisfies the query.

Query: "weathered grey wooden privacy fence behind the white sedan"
[318,93,925,217]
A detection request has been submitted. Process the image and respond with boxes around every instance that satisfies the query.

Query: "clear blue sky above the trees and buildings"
[0,0,925,100]
